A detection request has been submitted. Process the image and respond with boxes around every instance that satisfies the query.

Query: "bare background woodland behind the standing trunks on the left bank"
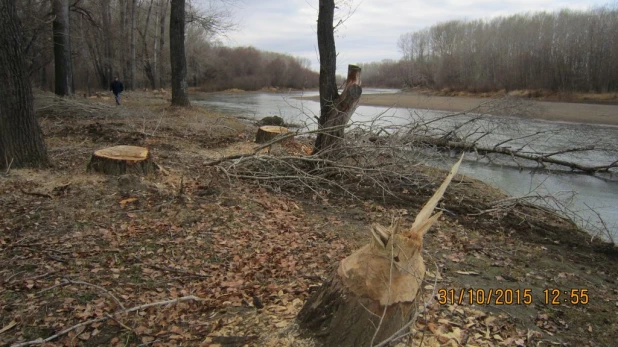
[16,0,318,91]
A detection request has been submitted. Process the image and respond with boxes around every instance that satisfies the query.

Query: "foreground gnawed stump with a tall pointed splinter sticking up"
[298,156,463,346]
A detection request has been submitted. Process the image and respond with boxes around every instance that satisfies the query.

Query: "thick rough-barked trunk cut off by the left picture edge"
[0,0,47,169]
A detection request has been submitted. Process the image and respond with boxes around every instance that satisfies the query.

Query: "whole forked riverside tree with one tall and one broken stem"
[313,0,362,155]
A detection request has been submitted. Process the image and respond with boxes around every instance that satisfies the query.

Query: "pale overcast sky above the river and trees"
[211,0,616,74]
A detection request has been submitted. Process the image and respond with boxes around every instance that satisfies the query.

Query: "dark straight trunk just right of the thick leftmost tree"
[52,0,73,96]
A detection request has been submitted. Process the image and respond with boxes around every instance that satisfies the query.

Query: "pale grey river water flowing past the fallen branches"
[193,88,618,241]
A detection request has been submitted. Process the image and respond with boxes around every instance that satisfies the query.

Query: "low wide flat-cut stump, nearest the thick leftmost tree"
[88,146,157,176]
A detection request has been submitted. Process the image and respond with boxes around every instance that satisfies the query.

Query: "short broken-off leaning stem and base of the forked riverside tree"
[313,65,363,154]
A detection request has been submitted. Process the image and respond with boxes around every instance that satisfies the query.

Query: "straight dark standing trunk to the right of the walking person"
[170,0,190,106]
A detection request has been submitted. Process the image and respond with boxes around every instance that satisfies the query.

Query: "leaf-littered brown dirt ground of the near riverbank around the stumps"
[0,92,618,346]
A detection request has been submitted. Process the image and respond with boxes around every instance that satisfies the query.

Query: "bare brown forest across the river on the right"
[361,7,618,92]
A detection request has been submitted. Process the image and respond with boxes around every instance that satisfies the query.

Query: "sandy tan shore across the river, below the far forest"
[296,92,618,126]
